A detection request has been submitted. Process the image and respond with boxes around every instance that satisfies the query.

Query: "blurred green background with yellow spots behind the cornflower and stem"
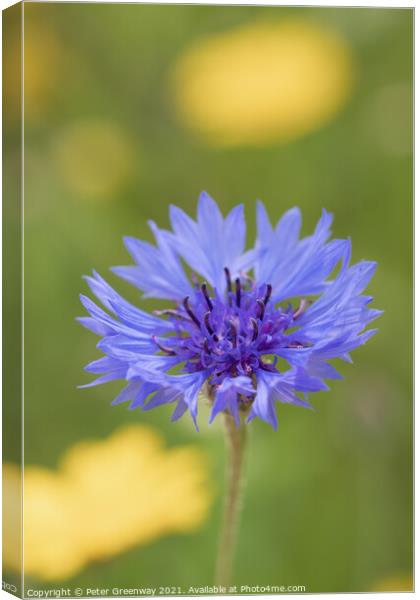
[4,3,413,592]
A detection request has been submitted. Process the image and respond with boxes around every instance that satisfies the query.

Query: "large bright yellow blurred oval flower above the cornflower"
[173,19,353,146]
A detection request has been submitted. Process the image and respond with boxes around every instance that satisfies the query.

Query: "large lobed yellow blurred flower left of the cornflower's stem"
[6,425,211,580]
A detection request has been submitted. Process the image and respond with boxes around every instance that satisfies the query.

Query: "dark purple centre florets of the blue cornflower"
[153,268,306,385]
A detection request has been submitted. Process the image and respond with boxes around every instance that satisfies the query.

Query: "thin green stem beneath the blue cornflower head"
[216,415,246,588]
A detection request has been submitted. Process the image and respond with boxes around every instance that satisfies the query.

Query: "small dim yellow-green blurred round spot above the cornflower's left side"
[52,119,137,199]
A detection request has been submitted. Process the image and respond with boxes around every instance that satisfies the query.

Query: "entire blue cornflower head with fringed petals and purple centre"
[79,193,381,428]
